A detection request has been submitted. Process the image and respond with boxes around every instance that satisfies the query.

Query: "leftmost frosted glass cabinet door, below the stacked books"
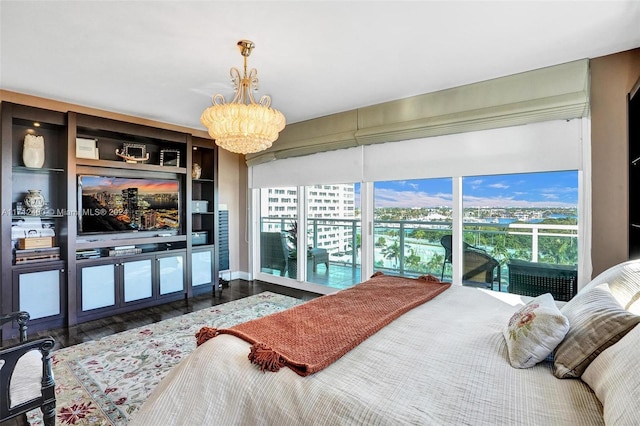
[18,269,60,320]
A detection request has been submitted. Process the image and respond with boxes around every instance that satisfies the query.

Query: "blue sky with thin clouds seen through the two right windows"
[368,171,578,208]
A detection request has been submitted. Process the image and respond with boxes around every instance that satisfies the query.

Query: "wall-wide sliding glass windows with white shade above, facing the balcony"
[249,119,591,292]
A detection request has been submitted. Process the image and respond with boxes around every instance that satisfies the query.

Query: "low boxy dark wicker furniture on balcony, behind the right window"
[509,259,578,301]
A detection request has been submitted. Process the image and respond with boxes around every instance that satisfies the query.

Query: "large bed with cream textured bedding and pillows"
[130,261,640,426]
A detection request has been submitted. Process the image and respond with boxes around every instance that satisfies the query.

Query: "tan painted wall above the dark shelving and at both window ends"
[6,48,640,276]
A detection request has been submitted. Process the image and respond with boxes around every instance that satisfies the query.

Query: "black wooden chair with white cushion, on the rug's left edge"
[0,311,56,426]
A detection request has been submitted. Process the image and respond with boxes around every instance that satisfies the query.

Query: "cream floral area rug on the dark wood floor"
[27,292,302,426]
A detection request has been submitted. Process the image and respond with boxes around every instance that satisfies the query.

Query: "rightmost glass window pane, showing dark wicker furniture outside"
[462,171,578,294]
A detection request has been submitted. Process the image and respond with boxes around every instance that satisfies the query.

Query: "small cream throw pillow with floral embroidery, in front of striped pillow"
[502,293,569,368]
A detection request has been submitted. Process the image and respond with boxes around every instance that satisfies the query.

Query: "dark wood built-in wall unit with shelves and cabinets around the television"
[0,101,219,328]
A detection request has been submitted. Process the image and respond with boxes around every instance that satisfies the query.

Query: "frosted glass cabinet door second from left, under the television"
[81,264,116,311]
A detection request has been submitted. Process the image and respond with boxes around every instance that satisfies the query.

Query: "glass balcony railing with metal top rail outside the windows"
[261,218,578,285]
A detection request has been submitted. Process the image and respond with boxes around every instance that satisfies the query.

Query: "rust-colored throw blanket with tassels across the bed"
[196,272,451,376]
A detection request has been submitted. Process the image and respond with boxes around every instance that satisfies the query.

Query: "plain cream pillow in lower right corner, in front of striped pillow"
[582,326,640,425]
